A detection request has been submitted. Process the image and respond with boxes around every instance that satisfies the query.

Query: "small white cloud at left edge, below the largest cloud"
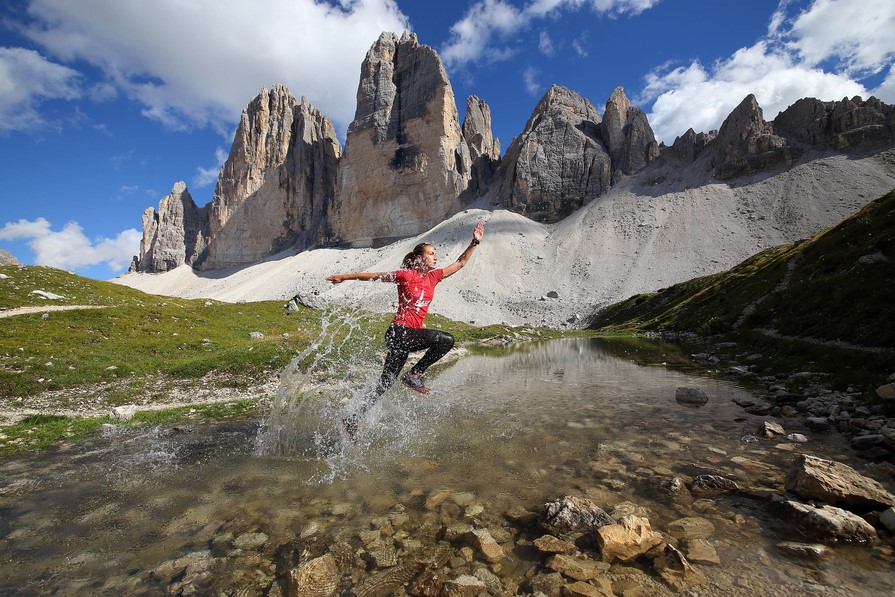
[0,48,81,133]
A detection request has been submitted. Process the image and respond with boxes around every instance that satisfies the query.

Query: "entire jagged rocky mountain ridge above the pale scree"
[131,32,895,280]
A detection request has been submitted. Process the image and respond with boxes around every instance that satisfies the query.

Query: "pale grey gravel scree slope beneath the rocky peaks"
[114,150,895,327]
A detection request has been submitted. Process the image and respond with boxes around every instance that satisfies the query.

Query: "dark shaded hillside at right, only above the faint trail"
[590,191,895,348]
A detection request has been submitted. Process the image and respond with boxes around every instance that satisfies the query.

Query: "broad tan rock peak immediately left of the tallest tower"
[196,85,342,269]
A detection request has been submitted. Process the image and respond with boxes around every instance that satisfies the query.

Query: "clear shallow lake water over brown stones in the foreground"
[0,339,895,595]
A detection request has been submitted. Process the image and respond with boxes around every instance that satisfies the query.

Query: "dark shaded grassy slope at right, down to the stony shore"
[590,191,895,400]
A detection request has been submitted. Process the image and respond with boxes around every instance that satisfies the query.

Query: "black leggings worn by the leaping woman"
[361,323,454,412]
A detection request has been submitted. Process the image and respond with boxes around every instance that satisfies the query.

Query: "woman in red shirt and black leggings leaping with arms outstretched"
[326,222,485,439]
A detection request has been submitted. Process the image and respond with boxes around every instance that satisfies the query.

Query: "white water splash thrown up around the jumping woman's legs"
[253,300,476,484]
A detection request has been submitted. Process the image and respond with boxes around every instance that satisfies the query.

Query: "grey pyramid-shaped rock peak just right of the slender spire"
[497,85,612,222]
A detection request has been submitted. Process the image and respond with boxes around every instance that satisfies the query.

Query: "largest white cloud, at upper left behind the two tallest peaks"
[18,0,409,135]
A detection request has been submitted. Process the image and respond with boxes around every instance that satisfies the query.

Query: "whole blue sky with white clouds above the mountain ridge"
[0,0,895,279]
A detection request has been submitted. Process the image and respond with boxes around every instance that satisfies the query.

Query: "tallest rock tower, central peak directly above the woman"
[330,33,471,246]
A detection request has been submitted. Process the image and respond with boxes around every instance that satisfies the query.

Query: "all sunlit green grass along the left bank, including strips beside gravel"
[0,266,562,456]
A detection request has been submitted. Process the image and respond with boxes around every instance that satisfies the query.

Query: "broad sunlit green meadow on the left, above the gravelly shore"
[0,267,336,397]
